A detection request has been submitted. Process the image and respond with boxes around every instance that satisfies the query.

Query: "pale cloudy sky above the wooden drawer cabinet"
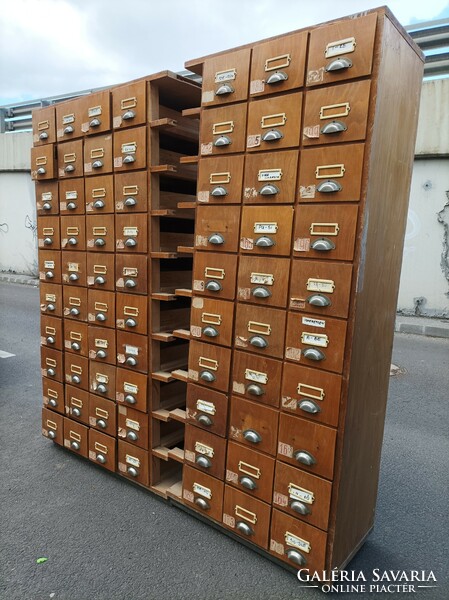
[0,0,449,106]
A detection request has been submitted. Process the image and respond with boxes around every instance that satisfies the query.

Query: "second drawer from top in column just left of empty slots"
[114,125,147,172]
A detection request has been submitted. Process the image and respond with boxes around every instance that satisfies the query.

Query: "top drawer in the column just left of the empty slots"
[112,80,147,129]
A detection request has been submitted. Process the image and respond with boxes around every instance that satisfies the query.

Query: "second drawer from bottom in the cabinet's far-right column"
[273,461,332,530]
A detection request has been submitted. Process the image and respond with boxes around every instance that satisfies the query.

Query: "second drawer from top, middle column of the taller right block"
[246,92,302,152]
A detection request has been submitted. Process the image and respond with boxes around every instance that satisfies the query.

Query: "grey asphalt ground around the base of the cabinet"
[0,283,449,600]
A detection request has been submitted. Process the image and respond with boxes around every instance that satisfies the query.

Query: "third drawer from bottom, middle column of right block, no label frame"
[229,396,279,456]
